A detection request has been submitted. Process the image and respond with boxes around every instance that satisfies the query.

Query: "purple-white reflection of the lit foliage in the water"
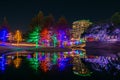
[85,56,120,73]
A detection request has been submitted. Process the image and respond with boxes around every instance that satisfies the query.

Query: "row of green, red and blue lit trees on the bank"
[28,28,85,47]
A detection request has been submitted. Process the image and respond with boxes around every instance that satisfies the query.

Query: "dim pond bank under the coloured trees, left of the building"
[0,46,72,54]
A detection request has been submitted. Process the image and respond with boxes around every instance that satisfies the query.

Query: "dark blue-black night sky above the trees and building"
[0,0,120,30]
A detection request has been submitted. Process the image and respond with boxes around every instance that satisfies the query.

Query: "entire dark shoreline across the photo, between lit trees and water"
[0,41,120,53]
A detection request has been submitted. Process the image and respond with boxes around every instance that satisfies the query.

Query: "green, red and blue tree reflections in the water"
[25,52,73,72]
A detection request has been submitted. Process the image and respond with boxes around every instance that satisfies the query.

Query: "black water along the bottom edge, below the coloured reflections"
[0,65,120,80]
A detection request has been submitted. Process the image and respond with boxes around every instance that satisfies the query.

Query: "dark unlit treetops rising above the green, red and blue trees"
[29,11,70,30]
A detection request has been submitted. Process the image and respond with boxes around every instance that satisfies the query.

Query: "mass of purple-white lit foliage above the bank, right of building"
[84,24,120,41]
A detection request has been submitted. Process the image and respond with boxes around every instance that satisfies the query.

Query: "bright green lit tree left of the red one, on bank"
[28,27,40,48]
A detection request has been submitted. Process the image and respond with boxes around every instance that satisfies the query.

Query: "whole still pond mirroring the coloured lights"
[0,42,120,80]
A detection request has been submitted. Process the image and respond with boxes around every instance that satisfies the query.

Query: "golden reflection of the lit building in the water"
[72,50,91,76]
